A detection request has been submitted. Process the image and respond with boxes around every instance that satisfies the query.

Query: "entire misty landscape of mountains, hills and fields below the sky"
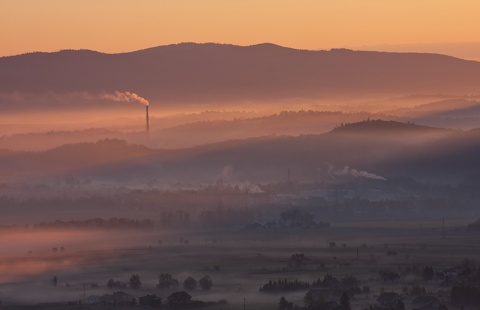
[0,43,480,310]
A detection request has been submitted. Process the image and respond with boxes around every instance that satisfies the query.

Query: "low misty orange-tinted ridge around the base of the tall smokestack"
[0,110,380,151]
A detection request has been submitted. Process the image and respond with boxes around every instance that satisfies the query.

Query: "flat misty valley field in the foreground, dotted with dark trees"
[0,220,480,309]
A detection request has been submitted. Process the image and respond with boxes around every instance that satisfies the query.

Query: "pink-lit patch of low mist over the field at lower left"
[0,229,162,283]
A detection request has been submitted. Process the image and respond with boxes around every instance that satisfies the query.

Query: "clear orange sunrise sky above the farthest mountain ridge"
[0,0,480,58]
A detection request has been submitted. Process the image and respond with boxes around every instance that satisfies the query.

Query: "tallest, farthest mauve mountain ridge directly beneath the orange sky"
[0,43,480,108]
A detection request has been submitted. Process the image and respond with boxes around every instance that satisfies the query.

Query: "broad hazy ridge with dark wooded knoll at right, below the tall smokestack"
[0,120,480,182]
